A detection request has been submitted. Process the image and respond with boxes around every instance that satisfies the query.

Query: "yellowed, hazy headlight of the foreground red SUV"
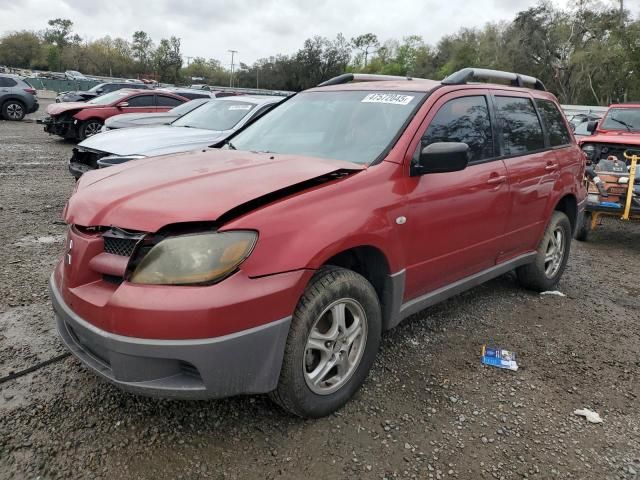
[130,231,258,285]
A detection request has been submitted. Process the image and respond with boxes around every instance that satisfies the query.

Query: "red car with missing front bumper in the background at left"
[41,89,188,141]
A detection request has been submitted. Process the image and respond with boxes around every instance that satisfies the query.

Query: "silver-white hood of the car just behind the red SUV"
[78,125,228,157]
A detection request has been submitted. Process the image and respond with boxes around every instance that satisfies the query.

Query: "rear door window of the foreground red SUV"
[495,97,545,155]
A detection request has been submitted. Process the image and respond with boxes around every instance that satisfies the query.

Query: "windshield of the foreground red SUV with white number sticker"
[231,91,425,164]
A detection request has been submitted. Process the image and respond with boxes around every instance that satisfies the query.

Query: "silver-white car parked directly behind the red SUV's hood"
[69,95,284,179]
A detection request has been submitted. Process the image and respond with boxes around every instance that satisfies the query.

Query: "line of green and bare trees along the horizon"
[0,0,640,105]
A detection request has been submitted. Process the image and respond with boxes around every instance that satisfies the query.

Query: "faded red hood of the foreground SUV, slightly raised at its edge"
[65,150,366,232]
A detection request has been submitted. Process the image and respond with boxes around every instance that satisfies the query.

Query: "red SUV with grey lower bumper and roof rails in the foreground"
[50,69,585,417]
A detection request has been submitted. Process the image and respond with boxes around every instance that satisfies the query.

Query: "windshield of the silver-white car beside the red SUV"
[171,100,256,130]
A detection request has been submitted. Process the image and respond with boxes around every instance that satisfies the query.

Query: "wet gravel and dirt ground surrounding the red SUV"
[0,106,640,480]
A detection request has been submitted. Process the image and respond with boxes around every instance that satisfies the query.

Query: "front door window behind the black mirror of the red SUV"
[422,95,494,162]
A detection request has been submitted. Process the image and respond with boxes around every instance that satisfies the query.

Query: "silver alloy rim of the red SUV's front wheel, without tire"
[302,298,367,395]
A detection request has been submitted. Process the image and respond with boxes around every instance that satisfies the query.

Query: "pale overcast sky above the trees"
[0,0,640,64]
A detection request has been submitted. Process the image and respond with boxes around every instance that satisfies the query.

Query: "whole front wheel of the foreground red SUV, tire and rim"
[270,267,382,418]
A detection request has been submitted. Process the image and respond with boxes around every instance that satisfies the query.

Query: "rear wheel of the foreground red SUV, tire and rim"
[516,211,571,292]
